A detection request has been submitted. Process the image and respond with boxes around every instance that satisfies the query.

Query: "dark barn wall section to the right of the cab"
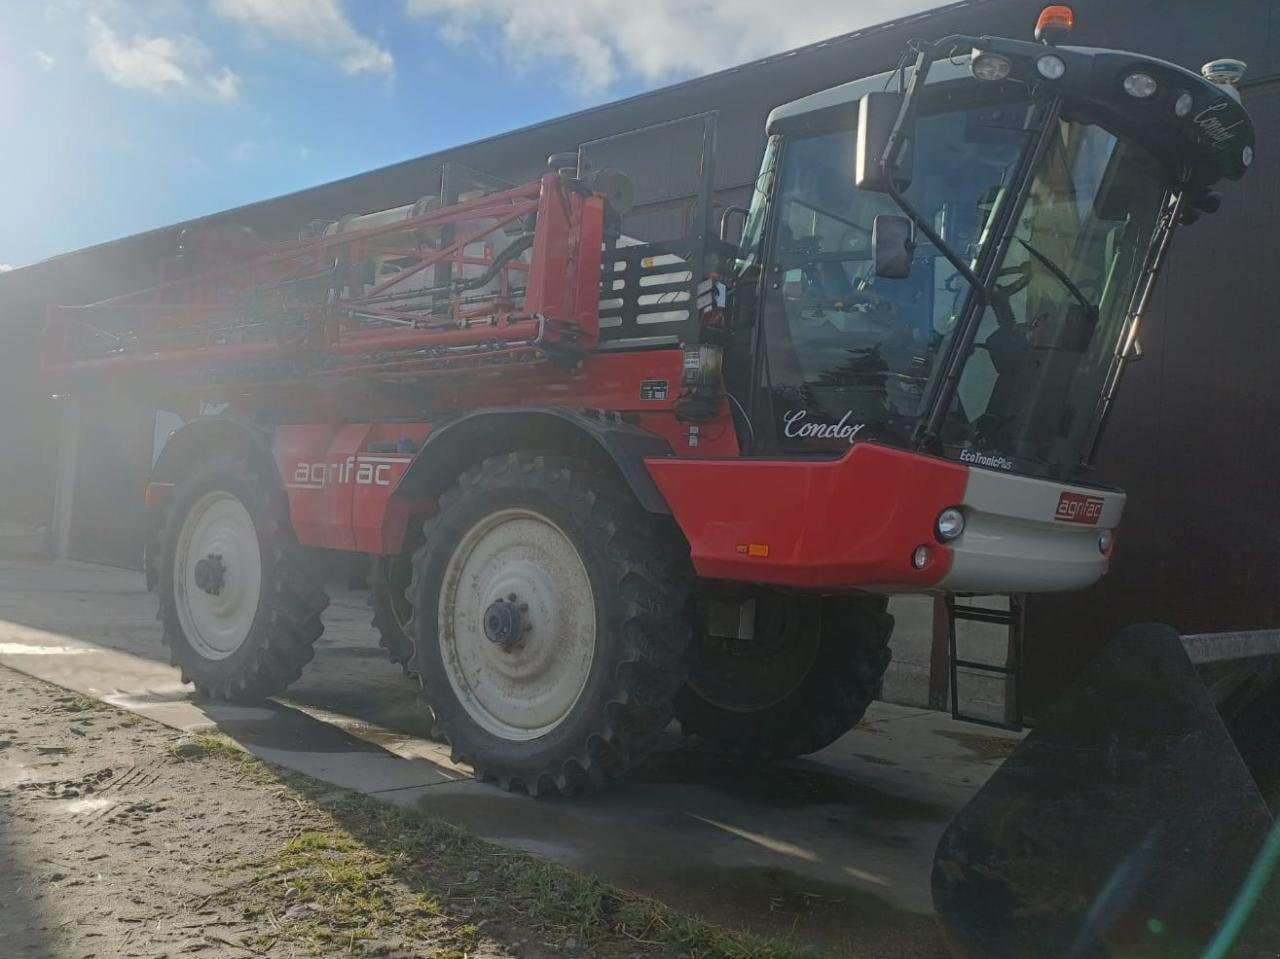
[1025,76,1280,704]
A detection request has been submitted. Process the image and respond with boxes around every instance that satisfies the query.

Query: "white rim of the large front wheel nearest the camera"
[438,508,595,741]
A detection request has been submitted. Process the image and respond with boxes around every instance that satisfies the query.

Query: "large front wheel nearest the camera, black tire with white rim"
[411,453,692,795]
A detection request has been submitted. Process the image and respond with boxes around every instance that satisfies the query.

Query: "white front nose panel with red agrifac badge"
[938,467,1125,593]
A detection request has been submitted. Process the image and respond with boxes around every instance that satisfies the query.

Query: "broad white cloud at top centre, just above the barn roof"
[404,0,942,93]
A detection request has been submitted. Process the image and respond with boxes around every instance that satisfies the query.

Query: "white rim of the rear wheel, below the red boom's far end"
[173,490,262,659]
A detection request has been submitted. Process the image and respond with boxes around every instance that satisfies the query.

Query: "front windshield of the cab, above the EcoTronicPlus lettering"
[942,120,1165,479]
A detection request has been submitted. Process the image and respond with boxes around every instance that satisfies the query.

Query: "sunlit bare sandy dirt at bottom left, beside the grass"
[0,670,507,959]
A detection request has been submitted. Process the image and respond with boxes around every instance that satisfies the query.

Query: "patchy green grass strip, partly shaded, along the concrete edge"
[223,771,813,959]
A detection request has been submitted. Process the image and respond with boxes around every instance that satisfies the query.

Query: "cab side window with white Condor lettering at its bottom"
[748,96,1032,452]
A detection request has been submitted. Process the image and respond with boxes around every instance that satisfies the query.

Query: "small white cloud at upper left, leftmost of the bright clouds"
[87,13,239,100]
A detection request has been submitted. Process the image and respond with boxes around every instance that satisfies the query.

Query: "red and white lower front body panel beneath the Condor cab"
[645,443,1124,593]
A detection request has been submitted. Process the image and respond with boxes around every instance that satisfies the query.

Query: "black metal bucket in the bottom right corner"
[933,625,1280,959]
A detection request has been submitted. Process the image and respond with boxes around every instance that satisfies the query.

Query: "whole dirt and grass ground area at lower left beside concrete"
[0,667,936,959]
